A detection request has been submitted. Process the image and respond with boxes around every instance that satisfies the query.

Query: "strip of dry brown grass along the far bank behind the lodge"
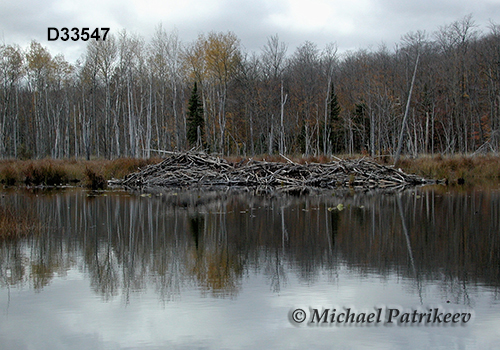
[0,154,500,189]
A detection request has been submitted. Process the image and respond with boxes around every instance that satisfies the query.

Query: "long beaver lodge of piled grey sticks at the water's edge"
[110,152,427,193]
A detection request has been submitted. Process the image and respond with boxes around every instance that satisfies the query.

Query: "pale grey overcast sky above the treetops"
[0,0,500,62]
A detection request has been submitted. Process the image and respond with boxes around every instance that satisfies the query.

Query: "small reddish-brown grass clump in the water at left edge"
[0,205,42,241]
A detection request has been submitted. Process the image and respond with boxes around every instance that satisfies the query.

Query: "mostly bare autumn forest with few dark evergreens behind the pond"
[0,15,500,159]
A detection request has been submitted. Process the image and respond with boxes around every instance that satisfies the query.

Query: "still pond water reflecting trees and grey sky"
[0,187,500,350]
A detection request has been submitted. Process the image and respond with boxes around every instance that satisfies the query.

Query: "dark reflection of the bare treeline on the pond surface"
[0,188,500,302]
